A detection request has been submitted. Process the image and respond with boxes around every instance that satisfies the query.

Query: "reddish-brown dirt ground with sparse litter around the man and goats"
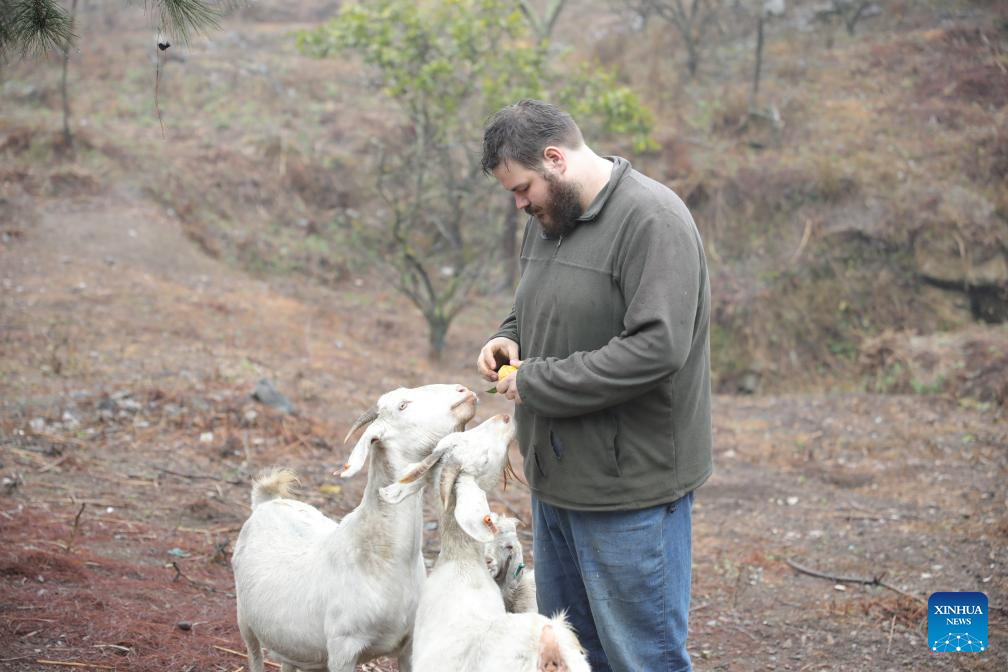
[0,177,1008,672]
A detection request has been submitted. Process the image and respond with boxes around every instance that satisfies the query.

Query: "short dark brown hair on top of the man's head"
[482,99,585,174]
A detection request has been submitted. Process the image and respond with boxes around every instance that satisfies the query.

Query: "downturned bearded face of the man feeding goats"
[493,163,584,238]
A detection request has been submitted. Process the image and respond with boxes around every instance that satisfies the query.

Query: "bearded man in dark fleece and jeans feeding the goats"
[477,100,712,672]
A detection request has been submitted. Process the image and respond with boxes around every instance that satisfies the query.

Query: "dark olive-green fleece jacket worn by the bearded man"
[495,157,712,511]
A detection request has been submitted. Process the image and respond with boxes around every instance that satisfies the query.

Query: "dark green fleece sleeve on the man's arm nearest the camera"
[517,211,706,417]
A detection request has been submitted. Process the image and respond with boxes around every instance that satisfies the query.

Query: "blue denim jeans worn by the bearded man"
[532,493,694,672]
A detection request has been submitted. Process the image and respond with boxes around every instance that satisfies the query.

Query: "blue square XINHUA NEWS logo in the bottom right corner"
[927,592,988,653]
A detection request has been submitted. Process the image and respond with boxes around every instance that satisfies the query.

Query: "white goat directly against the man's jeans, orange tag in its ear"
[381,415,589,672]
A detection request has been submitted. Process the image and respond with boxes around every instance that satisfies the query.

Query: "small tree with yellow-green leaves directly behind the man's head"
[298,0,653,358]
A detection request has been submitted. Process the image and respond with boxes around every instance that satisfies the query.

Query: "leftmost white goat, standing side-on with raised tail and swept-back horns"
[232,385,476,672]
